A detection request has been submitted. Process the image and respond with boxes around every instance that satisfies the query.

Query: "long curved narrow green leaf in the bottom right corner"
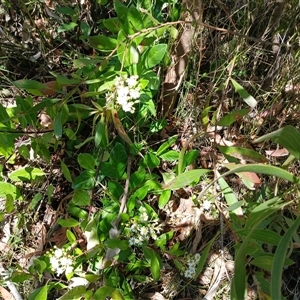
[271,217,300,299]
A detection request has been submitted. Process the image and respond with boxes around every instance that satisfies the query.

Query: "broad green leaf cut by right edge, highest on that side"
[254,125,300,159]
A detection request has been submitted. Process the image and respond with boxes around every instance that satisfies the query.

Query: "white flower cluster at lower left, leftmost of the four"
[47,246,74,276]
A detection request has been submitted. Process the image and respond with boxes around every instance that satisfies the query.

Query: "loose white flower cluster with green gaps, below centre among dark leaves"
[129,207,160,246]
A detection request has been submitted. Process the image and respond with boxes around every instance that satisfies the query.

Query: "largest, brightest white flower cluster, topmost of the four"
[106,75,141,113]
